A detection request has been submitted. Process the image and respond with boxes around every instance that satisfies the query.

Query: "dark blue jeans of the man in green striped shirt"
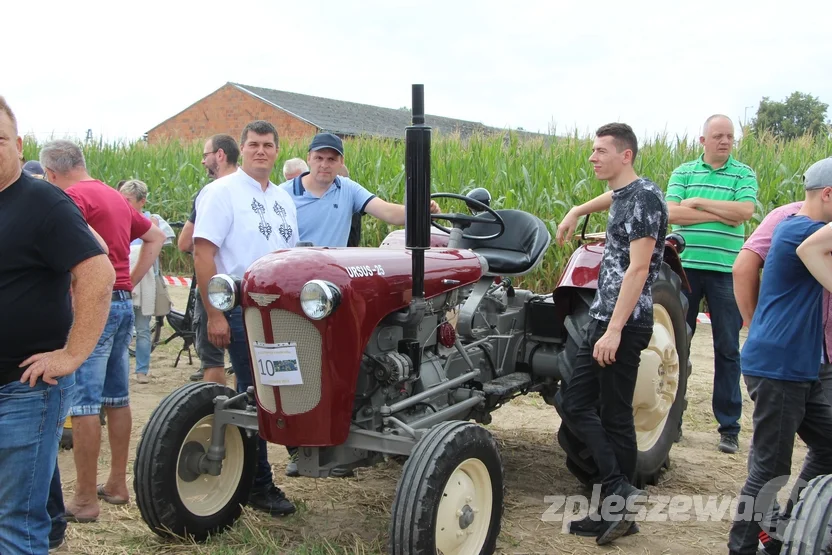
[685,268,742,435]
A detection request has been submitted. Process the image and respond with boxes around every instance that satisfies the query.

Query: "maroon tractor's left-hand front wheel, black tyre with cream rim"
[134,382,257,541]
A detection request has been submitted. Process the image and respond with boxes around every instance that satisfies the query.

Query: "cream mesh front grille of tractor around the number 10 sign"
[246,308,321,415]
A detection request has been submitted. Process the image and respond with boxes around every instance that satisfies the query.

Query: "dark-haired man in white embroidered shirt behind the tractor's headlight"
[194,121,298,515]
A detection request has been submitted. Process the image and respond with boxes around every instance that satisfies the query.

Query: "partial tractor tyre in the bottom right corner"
[780,474,832,555]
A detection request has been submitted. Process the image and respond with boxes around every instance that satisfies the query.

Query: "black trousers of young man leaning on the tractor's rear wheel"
[561,319,653,494]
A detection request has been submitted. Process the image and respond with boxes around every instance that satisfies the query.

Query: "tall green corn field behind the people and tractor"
[24,130,832,291]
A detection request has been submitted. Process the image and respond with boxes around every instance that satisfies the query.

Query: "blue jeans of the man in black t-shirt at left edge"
[0,375,75,555]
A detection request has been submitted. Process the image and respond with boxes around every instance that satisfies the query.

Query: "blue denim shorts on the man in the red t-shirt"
[69,300,133,416]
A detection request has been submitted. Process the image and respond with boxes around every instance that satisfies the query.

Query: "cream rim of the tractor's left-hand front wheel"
[176,414,245,516]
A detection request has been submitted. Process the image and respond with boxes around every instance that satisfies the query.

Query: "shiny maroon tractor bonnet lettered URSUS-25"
[241,247,482,446]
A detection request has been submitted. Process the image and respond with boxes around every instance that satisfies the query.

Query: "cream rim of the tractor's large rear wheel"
[633,304,680,451]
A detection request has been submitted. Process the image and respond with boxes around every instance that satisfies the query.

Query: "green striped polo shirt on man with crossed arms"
[665,155,757,272]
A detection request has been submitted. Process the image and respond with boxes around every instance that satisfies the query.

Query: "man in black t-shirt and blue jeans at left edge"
[0,97,115,554]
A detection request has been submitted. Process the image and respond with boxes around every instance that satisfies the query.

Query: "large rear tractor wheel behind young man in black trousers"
[556,263,692,487]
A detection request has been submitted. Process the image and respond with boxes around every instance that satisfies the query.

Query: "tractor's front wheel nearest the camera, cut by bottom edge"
[389,421,504,555]
